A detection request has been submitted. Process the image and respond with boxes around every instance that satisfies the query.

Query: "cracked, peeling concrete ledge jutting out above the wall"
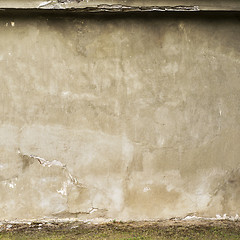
[0,0,240,12]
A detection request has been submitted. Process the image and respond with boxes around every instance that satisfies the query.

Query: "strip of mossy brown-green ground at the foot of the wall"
[0,220,240,240]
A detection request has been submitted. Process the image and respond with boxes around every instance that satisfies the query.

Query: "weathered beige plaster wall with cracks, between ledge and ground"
[0,12,240,220]
